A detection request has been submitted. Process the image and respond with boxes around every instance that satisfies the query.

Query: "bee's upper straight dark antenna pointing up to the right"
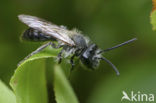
[98,38,137,54]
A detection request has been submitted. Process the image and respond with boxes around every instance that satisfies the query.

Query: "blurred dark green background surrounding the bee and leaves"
[0,0,156,103]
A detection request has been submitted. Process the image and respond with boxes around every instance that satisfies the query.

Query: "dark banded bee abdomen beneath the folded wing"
[22,28,56,41]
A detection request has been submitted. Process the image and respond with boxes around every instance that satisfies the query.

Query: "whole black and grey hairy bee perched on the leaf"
[18,14,136,75]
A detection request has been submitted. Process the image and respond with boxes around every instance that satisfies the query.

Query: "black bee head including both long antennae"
[80,38,137,75]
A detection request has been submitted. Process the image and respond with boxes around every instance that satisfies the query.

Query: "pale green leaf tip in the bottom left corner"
[0,80,16,103]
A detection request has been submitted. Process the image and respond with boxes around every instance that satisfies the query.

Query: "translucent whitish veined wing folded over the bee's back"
[18,15,75,46]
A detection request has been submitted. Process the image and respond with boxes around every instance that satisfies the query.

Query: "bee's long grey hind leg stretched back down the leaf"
[17,42,52,66]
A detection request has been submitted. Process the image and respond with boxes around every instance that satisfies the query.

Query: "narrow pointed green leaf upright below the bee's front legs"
[54,65,78,103]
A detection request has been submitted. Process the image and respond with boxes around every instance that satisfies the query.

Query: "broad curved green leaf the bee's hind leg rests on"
[10,48,58,103]
